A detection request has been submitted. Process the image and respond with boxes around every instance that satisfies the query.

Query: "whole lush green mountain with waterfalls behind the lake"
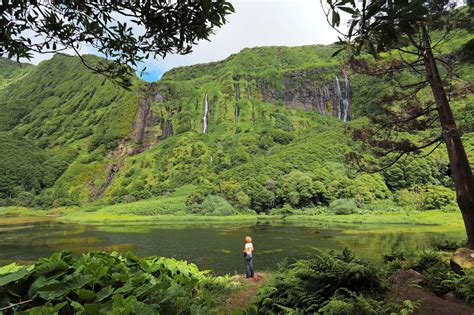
[0,27,474,214]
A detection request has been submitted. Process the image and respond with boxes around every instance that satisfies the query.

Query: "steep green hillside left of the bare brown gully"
[0,54,141,207]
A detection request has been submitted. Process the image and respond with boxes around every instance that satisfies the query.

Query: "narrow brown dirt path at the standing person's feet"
[227,272,268,314]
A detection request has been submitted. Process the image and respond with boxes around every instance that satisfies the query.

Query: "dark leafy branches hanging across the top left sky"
[0,0,234,83]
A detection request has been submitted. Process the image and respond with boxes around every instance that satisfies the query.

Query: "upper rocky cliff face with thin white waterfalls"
[137,46,352,139]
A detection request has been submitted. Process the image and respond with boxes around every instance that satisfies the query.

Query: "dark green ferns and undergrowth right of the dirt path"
[242,248,474,314]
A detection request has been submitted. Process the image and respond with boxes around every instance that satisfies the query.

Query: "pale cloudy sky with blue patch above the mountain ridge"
[24,0,337,82]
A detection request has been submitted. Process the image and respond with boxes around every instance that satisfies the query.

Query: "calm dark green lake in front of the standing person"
[0,221,465,274]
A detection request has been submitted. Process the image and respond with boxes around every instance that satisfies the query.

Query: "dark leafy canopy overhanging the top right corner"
[321,0,470,57]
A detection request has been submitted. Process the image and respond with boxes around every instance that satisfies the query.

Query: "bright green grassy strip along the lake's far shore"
[0,207,464,229]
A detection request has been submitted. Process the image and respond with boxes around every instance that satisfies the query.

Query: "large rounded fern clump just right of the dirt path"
[250,249,399,314]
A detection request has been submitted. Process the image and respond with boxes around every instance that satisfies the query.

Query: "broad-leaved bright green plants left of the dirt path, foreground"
[0,252,237,314]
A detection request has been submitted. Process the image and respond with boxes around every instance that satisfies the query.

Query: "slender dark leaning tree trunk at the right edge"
[421,26,474,249]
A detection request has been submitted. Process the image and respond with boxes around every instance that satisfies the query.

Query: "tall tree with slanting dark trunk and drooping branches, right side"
[321,0,474,248]
